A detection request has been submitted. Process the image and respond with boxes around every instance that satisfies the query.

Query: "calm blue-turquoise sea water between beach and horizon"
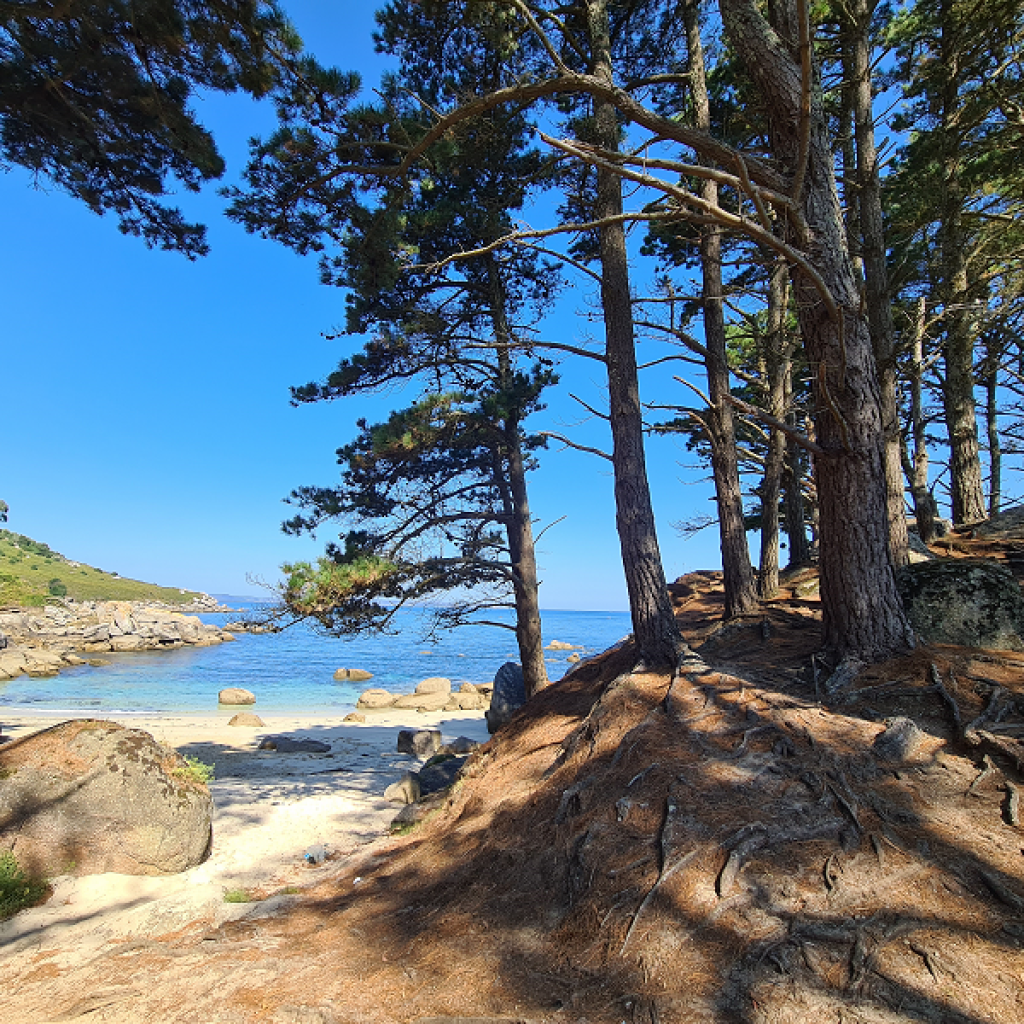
[0,609,632,721]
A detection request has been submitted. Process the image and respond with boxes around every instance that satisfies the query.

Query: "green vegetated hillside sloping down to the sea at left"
[0,529,201,608]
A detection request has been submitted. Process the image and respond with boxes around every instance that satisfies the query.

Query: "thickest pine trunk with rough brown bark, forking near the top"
[719,0,913,662]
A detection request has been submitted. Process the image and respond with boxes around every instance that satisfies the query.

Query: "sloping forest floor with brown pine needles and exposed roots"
[0,538,1024,1024]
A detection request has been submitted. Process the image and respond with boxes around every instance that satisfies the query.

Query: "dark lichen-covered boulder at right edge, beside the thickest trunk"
[896,558,1024,650]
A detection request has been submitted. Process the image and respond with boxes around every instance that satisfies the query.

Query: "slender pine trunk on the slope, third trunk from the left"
[683,0,761,618]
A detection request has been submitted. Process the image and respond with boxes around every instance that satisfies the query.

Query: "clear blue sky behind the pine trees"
[0,0,720,609]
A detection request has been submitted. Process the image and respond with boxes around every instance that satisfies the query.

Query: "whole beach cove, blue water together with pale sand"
[0,612,628,967]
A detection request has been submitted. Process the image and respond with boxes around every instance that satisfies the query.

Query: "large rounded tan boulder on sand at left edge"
[0,719,213,876]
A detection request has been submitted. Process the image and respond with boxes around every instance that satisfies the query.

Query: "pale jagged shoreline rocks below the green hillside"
[0,598,234,680]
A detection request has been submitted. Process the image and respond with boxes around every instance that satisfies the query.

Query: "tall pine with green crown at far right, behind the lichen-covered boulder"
[887,0,1024,523]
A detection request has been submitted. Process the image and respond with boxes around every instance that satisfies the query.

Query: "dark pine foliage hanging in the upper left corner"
[0,0,298,258]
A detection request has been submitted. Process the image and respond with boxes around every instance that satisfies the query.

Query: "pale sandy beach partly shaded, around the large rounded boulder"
[0,708,487,966]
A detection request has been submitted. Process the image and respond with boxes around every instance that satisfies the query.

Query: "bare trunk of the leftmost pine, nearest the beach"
[486,254,548,697]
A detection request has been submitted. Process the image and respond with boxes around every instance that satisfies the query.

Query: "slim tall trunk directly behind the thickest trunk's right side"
[846,0,909,566]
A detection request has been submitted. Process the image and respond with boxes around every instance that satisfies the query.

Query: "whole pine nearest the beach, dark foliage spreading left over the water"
[232,5,556,693]
